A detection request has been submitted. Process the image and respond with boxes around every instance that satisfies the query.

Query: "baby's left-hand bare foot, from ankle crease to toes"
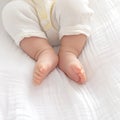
[33,48,58,84]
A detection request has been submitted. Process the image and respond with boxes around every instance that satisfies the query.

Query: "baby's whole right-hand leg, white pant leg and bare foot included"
[53,0,93,83]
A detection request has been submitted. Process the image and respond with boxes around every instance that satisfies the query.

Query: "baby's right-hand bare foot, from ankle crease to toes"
[59,51,86,84]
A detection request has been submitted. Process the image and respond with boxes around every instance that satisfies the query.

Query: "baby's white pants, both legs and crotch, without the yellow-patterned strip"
[2,0,93,45]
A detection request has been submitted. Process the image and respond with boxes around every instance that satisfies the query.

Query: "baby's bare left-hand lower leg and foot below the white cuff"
[20,37,58,84]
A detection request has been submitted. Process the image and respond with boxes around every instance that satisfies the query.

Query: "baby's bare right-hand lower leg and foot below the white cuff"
[59,34,86,83]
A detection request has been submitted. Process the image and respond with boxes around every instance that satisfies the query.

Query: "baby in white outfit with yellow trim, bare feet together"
[2,0,93,84]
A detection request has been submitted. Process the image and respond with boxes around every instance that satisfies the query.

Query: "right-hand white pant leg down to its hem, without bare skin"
[56,0,93,38]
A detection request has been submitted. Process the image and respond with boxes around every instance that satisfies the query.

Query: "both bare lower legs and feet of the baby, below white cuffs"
[20,35,87,84]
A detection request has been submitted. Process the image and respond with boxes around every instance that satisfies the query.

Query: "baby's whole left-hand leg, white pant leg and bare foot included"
[2,0,58,83]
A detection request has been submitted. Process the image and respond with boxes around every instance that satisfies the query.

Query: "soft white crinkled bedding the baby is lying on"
[0,0,120,120]
